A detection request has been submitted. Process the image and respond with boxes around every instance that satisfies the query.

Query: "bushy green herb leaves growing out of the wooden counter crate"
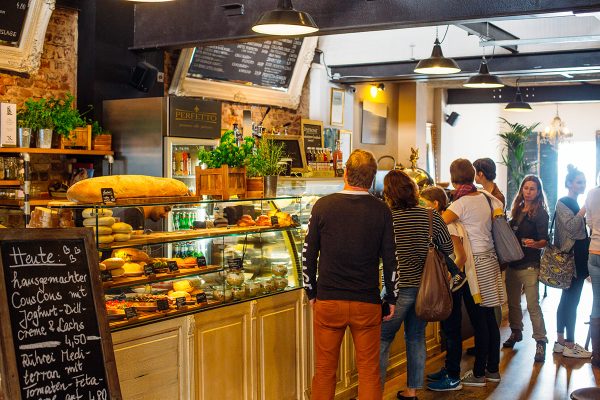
[198,131,254,168]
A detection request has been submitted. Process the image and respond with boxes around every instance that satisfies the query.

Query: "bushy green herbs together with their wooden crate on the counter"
[196,130,254,200]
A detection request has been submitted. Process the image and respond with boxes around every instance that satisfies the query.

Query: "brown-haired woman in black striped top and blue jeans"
[379,170,453,400]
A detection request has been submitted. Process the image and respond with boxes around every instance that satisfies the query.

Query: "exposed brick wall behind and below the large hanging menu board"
[165,51,309,135]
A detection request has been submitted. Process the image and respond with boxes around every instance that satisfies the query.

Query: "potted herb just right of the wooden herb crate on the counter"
[246,139,285,197]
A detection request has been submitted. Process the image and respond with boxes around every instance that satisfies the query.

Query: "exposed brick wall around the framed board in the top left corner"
[0,8,78,105]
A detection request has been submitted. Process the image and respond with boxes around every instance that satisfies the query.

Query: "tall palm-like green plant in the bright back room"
[498,118,540,203]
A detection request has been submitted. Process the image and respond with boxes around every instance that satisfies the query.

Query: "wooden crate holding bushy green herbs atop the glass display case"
[196,165,246,200]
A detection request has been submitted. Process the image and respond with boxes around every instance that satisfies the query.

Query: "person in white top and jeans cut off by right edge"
[585,176,600,368]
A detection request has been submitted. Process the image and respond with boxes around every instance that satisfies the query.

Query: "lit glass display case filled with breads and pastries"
[51,196,302,331]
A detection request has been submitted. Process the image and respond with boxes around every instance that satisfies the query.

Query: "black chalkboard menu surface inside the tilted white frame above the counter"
[188,38,302,89]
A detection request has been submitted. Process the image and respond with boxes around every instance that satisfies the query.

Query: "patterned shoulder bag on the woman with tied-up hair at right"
[538,211,575,289]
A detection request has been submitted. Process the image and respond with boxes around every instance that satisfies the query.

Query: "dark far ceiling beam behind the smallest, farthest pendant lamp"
[447,85,600,104]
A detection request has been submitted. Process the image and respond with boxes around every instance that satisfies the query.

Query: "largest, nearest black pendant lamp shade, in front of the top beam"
[252,0,319,36]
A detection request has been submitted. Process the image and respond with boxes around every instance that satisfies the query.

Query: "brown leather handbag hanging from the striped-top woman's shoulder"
[415,209,452,321]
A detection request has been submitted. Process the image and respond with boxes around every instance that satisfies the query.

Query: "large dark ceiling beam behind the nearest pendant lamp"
[133,0,600,49]
